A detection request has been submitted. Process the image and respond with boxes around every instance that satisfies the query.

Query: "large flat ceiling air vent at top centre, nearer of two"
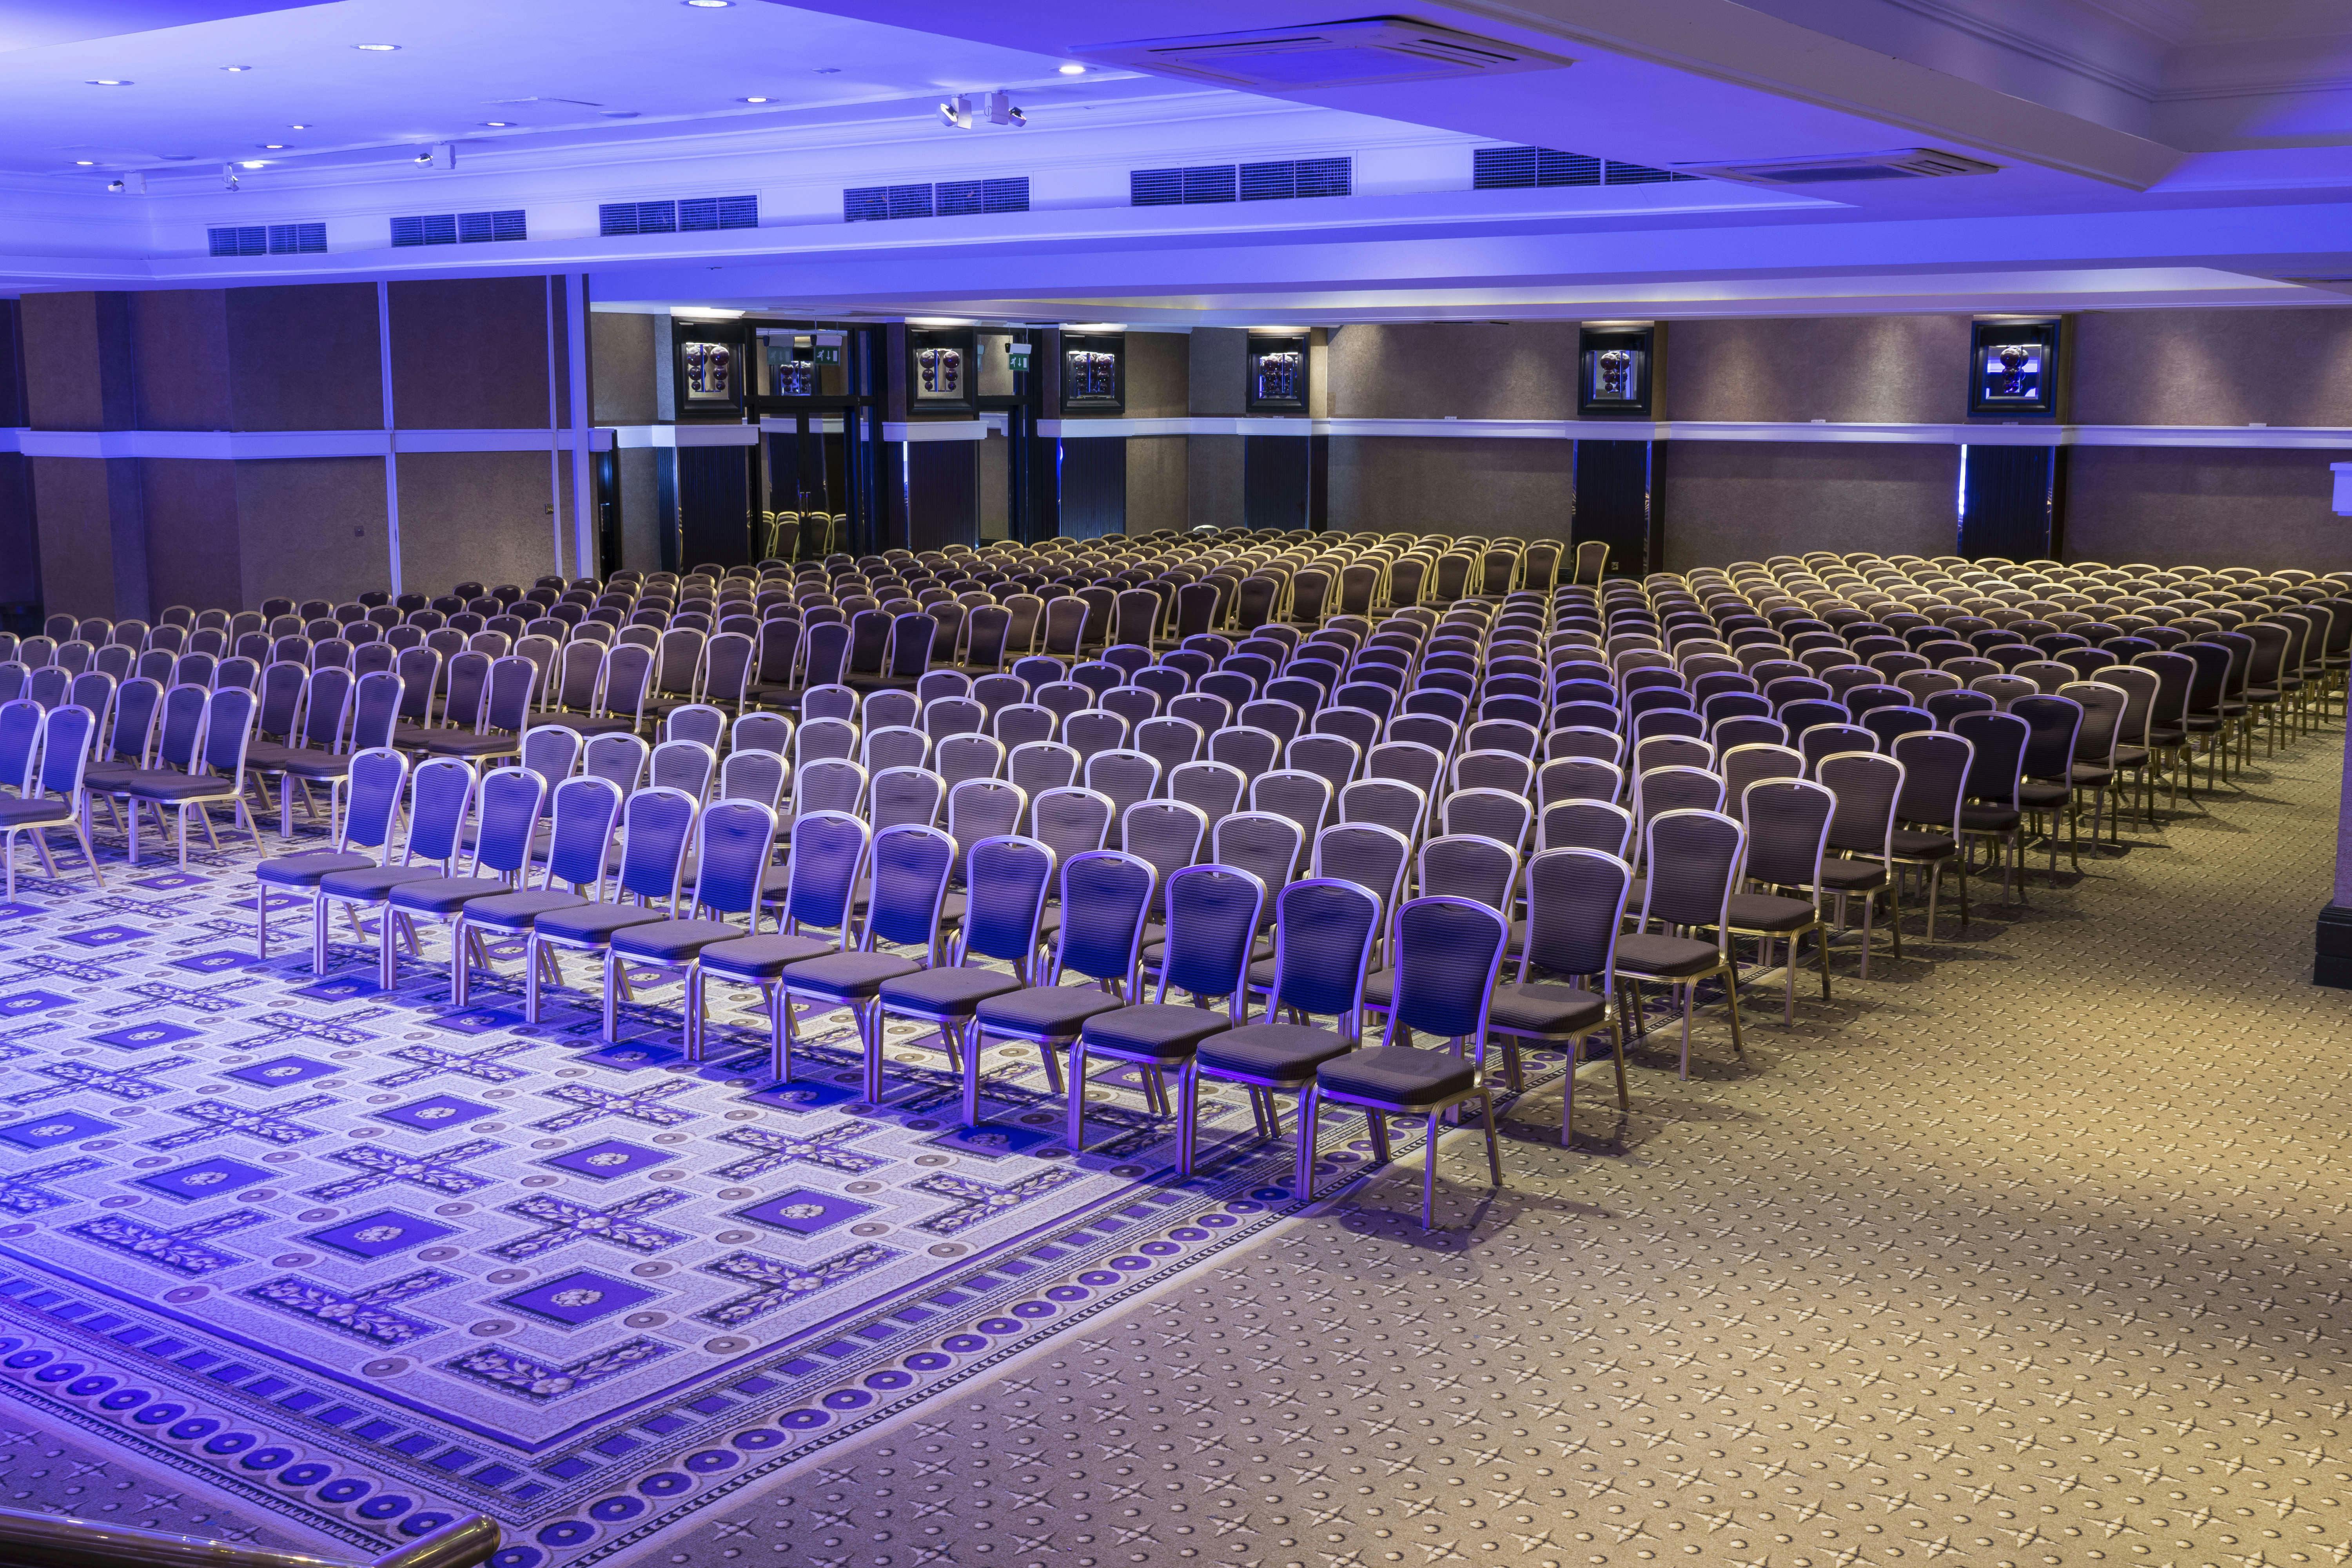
[1073,16,1571,92]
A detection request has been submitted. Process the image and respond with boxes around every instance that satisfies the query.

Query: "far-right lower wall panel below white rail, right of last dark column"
[2065,444,2352,571]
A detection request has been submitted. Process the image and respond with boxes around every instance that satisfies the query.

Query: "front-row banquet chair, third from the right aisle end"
[1063,863,1265,1176]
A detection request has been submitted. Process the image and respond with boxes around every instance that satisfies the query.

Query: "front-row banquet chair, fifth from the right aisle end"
[877,835,1054,1129]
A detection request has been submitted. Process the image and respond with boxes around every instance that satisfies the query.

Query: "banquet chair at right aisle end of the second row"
[1486,846,1632,1147]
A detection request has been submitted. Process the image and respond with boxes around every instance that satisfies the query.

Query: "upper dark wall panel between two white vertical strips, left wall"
[388,278,548,425]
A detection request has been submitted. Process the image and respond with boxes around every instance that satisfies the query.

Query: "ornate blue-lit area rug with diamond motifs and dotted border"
[0,835,1564,1568]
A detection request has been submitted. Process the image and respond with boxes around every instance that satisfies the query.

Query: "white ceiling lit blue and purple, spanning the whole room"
[0,0,2352,325]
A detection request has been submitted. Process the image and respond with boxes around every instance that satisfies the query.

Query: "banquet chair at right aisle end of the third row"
[1618,809,1748,1077]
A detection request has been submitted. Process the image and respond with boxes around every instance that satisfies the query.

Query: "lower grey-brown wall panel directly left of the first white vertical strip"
[232,458,393,606]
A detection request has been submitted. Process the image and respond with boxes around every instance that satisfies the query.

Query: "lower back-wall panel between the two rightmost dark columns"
[1663,442,1959,571]
